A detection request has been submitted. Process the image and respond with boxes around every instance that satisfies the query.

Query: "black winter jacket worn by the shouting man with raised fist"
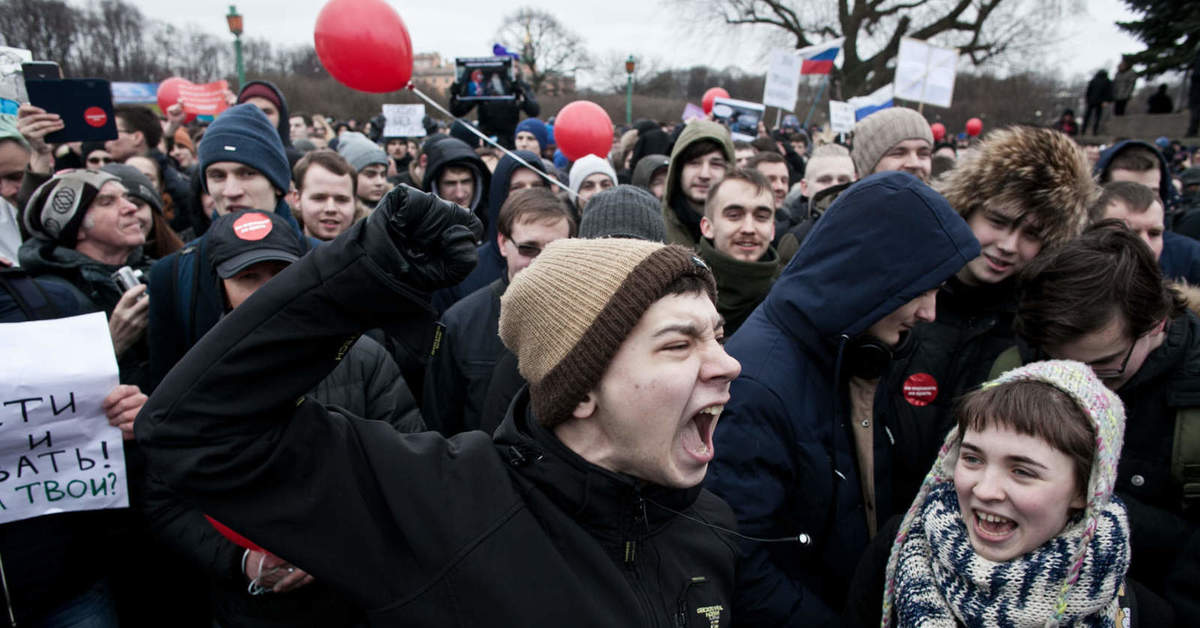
[136,213,737,627]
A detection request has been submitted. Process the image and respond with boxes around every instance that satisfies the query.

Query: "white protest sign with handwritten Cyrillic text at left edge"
[0,312,130,524]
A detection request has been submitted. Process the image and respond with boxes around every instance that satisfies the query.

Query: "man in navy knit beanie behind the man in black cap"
[148,104,307,384]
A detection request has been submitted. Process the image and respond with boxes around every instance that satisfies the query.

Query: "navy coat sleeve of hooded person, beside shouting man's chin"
[706,377,835,626]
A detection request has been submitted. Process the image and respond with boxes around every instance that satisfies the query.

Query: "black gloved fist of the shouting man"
[373,185,484,291]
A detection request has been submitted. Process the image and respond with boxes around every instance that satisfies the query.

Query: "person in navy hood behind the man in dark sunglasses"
[427,148,553,312]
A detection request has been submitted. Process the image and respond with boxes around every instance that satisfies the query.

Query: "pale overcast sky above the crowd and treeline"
[132,0,1141,84]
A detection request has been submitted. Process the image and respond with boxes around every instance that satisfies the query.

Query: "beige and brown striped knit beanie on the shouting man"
[500,238,716,427]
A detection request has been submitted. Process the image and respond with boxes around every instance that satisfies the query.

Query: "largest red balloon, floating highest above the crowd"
[312,0,413,94]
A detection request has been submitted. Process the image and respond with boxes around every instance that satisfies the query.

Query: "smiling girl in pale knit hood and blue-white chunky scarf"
[882,360,1129,626]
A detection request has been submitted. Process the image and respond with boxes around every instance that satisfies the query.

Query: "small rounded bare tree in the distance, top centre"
[496,7,589,91]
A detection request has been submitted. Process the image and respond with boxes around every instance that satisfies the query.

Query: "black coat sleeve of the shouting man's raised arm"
[136,213,521,611]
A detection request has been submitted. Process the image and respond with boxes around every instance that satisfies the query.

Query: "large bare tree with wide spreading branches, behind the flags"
[691,0,1078,97]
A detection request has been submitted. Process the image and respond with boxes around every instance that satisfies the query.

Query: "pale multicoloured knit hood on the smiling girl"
[883,360,1124,626]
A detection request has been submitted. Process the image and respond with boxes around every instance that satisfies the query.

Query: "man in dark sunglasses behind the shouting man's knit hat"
[421,184,575,436]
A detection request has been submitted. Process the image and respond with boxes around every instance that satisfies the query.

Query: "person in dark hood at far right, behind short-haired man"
[1092,139,1200,286]
